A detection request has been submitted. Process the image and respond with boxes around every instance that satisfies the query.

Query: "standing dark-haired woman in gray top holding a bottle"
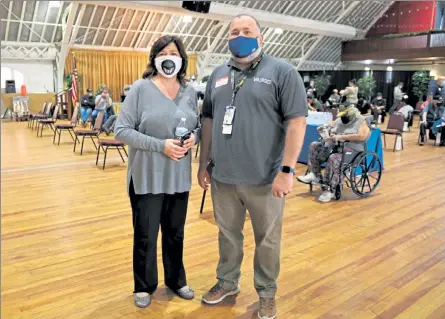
[114,35,200,308]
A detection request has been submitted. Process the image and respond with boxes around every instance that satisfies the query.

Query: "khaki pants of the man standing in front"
[211,178,285,297]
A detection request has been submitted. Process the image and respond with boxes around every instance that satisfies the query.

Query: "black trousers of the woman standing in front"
[130,180,189,294]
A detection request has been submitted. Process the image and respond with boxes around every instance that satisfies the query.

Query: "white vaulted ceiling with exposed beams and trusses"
[0,0,393,70]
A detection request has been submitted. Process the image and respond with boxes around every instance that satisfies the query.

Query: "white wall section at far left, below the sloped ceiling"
[1,60,54,93]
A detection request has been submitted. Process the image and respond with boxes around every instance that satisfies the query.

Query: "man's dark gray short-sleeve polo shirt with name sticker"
[202,54,308,185]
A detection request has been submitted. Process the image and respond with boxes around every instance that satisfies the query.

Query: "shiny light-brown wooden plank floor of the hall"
[1,122,445,319]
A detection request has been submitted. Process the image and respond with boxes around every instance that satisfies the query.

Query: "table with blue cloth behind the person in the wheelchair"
[298,125,385,169]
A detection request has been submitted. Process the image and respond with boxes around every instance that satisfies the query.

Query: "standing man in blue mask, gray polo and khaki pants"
[198,14,308,319]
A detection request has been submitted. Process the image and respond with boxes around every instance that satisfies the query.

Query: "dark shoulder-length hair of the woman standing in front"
[142,35,188,84]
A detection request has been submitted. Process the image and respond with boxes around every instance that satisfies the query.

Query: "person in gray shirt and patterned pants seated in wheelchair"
[297,105,370,202]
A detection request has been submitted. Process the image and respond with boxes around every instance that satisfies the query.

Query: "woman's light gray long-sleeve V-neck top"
[114,79,200,194]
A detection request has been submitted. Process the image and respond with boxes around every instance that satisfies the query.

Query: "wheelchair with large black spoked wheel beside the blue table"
[306,141,383,200]
